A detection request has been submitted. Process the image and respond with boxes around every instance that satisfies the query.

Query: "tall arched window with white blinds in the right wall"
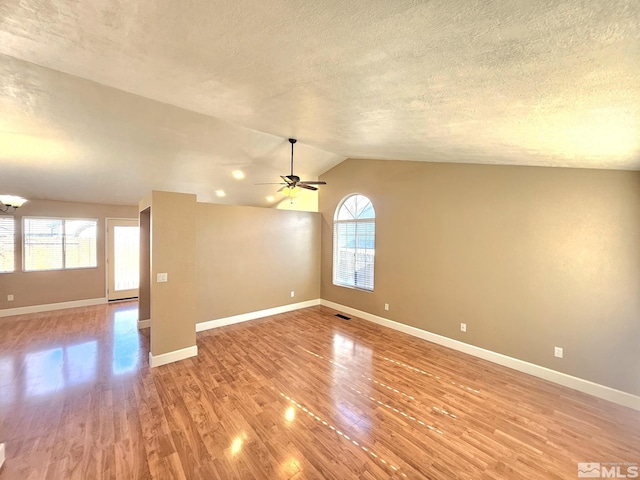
[333,194,376,291]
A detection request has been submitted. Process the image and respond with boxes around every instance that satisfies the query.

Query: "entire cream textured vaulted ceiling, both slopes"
[0,0,640,205]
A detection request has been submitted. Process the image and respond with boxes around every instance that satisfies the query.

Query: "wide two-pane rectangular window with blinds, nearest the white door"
[23,217,98,272]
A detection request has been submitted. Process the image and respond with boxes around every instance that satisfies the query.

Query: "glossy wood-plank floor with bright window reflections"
[0,303,640,480]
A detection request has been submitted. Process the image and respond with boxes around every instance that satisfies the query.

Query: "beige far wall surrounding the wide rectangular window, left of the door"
[0,200,138,310]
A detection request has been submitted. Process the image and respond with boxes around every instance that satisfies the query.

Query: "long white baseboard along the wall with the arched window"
[320,299,640,410]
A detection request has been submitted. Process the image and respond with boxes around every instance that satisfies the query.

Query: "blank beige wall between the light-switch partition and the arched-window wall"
[196,203,320,322]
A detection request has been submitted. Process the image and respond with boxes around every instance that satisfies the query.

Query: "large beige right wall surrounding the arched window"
[320,160,640,395]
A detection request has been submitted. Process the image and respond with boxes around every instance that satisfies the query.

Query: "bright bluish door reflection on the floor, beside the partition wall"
[111,308,140,375]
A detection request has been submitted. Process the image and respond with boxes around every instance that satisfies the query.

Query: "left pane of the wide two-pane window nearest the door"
[24,218,63,272]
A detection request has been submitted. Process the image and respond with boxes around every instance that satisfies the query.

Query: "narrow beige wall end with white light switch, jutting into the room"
[148,191,196,356]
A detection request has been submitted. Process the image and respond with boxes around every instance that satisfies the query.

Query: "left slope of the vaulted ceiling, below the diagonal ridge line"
[0,55,343,206]
